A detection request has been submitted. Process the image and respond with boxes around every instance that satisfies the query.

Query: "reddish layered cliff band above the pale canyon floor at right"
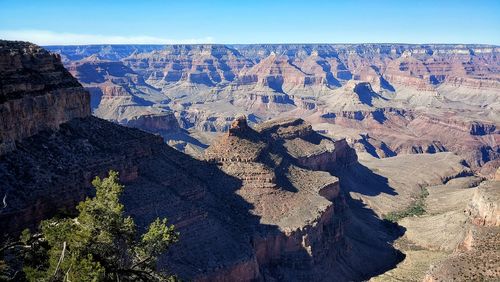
[314,108,500,170]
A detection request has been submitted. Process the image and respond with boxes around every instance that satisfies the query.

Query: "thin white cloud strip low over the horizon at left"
[0,30,214,45]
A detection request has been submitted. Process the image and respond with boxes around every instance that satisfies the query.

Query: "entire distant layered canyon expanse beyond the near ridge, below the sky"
[48,44,500,174]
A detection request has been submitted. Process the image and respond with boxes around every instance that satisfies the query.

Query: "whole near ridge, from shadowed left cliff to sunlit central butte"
[0,41,410,281]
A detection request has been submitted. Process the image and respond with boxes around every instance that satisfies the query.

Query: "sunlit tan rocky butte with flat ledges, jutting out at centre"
[205,117,398,281]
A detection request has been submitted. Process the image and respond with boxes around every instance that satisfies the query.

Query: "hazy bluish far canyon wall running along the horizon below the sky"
[49,44,499,94]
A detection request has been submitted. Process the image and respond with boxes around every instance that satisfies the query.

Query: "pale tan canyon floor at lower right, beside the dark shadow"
[350,153,500,281]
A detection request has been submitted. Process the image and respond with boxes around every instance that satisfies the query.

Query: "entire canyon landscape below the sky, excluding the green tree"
[0,41,500,281]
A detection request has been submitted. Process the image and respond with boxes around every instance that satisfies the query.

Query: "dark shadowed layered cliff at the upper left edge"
[0,41,90,154]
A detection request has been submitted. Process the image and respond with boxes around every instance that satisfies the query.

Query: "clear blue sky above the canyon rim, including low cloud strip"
[0,0,500,45]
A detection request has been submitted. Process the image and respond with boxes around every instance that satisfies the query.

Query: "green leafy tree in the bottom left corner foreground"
[0,171,178,281]
